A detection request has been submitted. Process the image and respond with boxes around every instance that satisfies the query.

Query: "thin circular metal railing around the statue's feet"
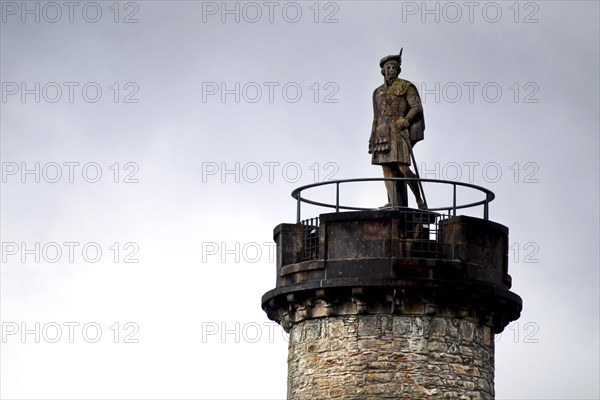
[292,178,496,223]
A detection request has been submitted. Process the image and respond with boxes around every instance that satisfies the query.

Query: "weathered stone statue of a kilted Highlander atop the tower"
[369,50,427,209]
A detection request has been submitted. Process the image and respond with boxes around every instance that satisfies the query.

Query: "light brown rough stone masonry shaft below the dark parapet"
[288,314,494,400]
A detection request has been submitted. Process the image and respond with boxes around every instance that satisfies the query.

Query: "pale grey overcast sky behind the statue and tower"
[0,1,600,399]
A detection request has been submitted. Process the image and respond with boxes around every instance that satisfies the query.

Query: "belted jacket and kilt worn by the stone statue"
[369,78,425,165]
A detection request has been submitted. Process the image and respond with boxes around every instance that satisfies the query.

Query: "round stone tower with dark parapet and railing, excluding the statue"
[262,180,522,400]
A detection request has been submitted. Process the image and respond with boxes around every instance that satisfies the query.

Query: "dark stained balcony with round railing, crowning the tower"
[262,178,522,332]
